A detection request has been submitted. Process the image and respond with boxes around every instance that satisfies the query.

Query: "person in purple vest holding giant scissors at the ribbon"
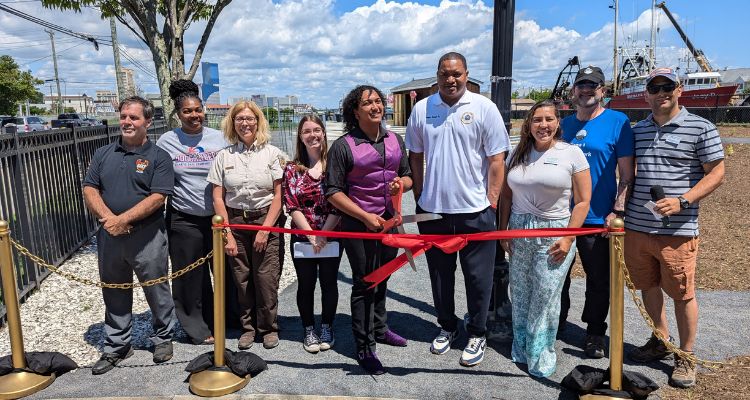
[326,85,412,375]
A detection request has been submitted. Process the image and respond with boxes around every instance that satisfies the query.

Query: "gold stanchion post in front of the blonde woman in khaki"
[190,215,250,397]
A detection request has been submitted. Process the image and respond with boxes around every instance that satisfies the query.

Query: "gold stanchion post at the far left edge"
[0,221,55,399]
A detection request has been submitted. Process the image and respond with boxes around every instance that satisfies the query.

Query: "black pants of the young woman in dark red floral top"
[290,235,342,327]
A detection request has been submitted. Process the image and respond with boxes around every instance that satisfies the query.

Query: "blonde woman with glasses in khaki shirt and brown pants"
[208,101,286,350]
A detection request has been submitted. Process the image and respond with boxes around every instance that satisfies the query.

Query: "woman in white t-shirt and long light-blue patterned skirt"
[500,100,591,377]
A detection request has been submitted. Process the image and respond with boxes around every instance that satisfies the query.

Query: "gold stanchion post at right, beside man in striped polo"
[580,218,630,400]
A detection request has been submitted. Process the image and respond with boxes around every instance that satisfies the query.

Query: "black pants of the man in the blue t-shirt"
[560,225,609,336]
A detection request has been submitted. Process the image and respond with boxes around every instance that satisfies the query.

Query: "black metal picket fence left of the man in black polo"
[0,121,167,318]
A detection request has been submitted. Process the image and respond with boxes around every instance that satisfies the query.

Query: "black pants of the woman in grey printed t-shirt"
[167,207,214,344]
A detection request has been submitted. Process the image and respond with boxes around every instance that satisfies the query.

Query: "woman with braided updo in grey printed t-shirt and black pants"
[156,79,228,344]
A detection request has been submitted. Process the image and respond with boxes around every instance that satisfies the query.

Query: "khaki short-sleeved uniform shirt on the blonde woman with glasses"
[208,142,287,210]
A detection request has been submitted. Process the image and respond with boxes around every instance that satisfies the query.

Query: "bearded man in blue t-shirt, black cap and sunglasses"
[560,66,635,358]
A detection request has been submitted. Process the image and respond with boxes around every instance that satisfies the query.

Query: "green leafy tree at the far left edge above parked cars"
[0,55,44,115]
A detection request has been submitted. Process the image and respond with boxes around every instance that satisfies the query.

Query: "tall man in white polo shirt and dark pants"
[406,52,510,366]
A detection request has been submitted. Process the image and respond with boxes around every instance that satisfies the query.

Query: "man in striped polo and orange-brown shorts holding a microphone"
[625,68,724,388]
